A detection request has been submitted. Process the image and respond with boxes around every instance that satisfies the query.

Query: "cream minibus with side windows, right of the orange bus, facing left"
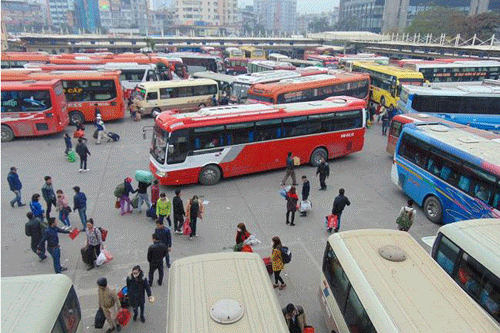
[136,79,219,114]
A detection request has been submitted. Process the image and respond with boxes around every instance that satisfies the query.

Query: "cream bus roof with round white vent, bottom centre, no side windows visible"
[167,252,289,333]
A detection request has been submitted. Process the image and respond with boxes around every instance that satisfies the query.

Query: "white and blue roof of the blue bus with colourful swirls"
[404,123,500,170]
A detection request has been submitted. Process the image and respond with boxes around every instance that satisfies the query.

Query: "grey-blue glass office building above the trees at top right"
[339,0,500,33]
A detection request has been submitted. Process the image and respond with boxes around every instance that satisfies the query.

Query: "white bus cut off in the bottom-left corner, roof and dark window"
[2,274,83,333]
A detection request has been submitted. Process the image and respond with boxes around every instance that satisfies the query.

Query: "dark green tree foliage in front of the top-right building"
[405,7,500,39]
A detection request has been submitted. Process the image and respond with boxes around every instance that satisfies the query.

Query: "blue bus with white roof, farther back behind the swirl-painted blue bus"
[397,80,500,132]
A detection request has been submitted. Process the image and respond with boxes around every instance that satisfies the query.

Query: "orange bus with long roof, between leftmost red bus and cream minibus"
[2,70,126,124]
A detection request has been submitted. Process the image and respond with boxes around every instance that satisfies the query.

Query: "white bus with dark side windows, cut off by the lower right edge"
[432,219,500,323]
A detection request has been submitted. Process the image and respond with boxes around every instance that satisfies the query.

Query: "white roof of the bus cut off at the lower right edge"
[438,219,500,276]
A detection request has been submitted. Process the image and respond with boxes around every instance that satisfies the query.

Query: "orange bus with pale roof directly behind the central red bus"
[247,72,370,104]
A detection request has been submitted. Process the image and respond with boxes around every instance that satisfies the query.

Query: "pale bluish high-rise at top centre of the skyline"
[254,0,297,33]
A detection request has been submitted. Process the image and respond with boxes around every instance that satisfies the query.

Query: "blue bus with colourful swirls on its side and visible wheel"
[391,123,500,224]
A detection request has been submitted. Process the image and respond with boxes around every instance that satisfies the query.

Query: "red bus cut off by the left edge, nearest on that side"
[1,80,69,142]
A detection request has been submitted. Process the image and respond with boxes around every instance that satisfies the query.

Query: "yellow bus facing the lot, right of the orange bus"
[351,61,424,107]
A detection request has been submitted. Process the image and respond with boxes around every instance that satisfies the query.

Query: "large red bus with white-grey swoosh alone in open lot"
[149,96,366,185]
